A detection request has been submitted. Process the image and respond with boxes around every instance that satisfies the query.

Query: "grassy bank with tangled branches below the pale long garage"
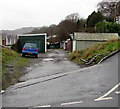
[68,39,120,67]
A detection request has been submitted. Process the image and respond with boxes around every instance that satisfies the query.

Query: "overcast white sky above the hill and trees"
[0,0,102,29]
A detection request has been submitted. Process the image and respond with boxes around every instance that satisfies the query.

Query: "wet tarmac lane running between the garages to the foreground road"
[20,50,80,81]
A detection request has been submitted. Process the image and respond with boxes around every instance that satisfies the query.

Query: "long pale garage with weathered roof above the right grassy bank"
[72,33,119,51]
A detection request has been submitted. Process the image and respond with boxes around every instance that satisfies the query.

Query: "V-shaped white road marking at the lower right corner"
[94,83,120,101]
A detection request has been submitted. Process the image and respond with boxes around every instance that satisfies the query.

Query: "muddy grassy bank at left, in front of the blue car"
[0,47,29,89]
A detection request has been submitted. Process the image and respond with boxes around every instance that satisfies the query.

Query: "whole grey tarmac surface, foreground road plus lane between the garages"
[2,50,120,109]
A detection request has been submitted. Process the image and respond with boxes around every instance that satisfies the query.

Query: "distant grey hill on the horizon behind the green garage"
[0,27,40,35]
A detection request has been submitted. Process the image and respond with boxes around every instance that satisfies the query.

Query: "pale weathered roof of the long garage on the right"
[73,33,119,40]
